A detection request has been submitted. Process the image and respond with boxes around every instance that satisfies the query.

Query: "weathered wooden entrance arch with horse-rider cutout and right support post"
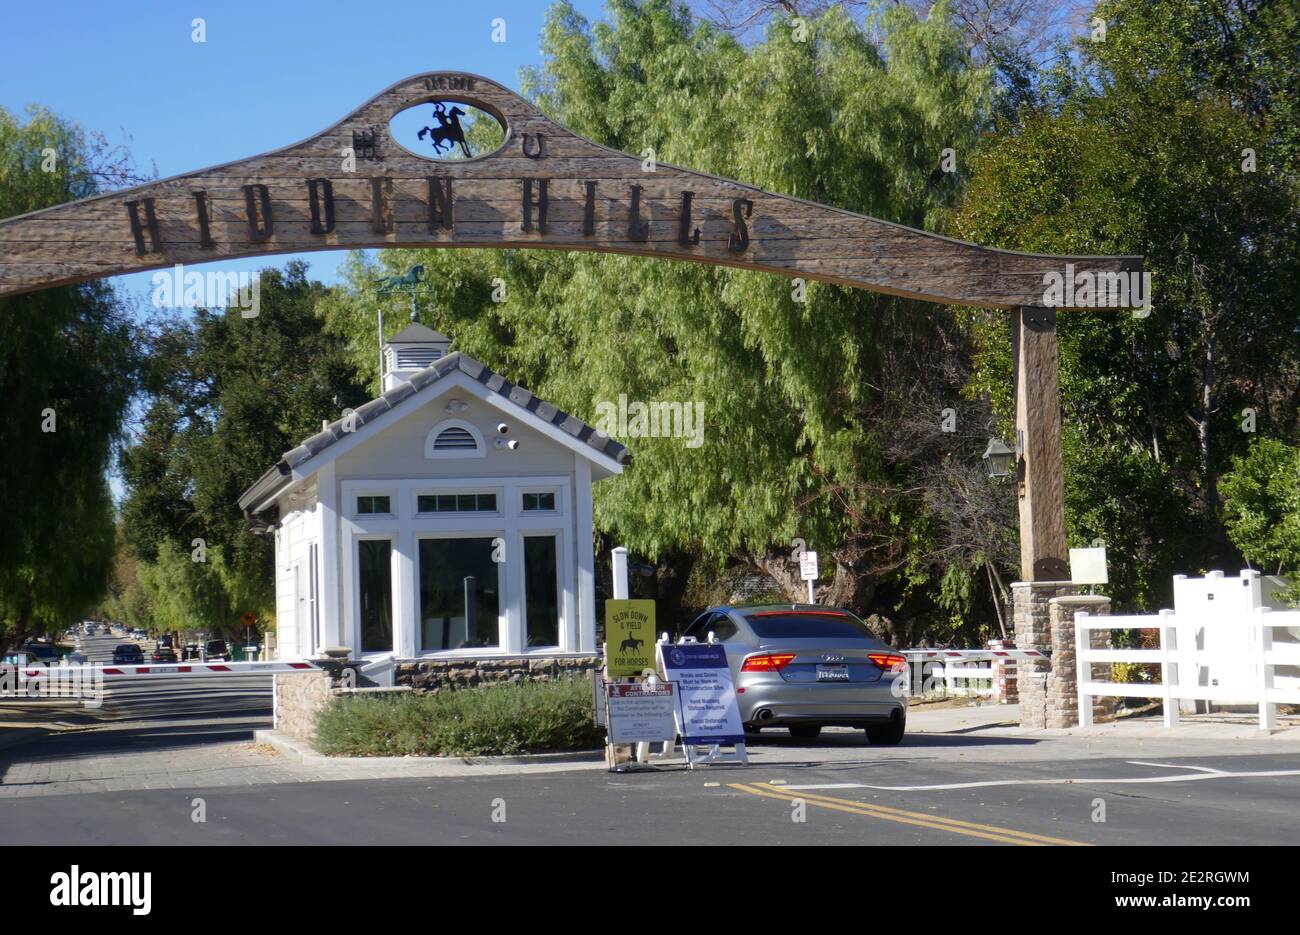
[0,72,1141,579]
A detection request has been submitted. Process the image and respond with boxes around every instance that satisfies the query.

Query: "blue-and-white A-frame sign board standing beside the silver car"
[659,642,749,767]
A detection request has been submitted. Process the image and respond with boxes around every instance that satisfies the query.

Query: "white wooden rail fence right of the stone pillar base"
[1074,607,1300,730]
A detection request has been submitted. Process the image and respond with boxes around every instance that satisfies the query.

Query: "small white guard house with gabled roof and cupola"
[239,323,628,670]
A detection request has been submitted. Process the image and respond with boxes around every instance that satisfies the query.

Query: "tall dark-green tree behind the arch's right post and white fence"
[954,0,1300,607]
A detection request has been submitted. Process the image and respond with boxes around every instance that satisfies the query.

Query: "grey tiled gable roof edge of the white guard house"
[239,351,632,519]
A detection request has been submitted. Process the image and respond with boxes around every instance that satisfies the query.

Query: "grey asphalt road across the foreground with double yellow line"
[0,756,1300,847]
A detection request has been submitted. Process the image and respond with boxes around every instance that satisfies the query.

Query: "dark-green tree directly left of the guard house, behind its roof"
[121,263,368,635]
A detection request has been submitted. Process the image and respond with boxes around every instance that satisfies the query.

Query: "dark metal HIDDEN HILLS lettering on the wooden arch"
[122,176,754,256]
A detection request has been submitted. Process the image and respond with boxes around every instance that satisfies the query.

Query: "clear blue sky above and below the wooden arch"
[0,0,603,300]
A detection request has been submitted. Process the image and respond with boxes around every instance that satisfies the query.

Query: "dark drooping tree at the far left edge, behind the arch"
[0,108,138,644]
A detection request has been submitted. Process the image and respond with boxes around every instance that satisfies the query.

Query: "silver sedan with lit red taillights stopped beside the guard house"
[685,603,907,744]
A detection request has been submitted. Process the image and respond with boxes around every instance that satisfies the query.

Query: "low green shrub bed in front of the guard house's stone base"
[316,679,605,757]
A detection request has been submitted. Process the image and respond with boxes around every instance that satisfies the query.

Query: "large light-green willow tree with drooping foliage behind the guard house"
[326,0,988,639]
